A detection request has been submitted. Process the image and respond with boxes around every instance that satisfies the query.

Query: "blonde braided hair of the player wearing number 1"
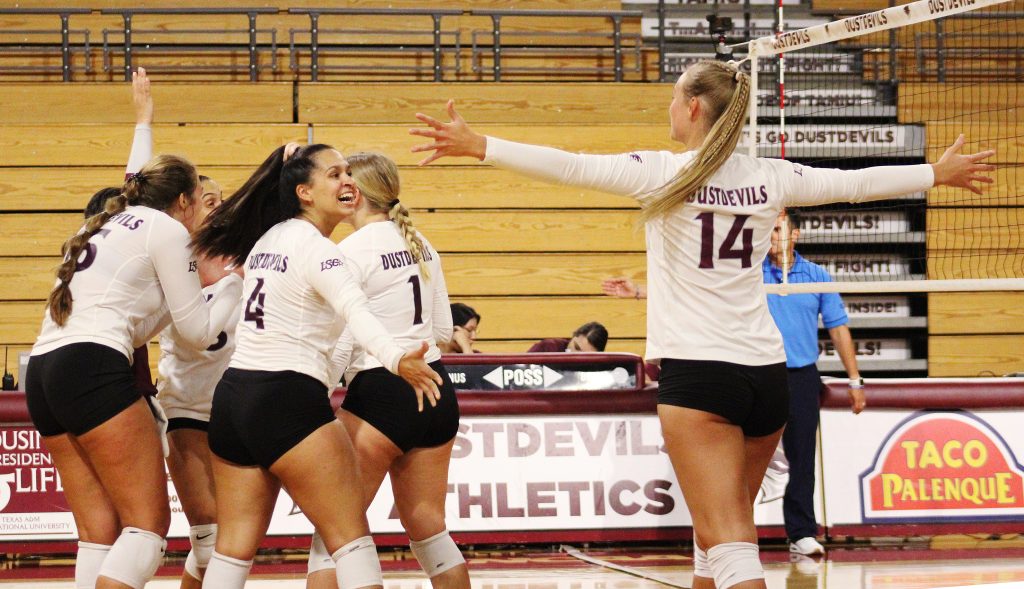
[346,153,430,280]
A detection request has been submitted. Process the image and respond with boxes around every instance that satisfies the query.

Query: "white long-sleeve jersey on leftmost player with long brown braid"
[32,207,242,361]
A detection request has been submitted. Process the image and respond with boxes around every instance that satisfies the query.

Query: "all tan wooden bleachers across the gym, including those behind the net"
[0,0,1024,376]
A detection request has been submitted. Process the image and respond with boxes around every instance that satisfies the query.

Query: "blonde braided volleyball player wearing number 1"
[306,154,469,589]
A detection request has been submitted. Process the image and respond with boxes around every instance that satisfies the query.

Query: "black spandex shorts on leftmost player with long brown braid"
[25,342,142,435]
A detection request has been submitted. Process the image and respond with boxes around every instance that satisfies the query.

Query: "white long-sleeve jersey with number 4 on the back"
[229,219,404,386]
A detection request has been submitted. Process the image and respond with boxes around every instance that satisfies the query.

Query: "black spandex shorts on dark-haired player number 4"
[208,368,335,469]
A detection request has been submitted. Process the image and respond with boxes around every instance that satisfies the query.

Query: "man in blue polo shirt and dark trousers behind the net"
[762,209,864,555]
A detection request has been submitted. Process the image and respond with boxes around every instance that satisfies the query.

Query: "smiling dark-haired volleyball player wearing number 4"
[194,144,443,589]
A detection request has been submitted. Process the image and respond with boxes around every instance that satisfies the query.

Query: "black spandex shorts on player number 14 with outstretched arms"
[657,359,790,437]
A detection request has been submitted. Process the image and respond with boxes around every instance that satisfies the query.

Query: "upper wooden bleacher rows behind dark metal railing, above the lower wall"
[0,0,657,81]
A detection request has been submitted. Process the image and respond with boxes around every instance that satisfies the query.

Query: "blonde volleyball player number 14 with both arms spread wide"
[411,61,993,589]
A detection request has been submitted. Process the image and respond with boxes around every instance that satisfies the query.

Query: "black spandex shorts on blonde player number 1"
[341,361,459,452]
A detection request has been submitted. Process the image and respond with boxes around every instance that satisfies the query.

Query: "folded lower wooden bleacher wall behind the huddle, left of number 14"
[0,81,659,376]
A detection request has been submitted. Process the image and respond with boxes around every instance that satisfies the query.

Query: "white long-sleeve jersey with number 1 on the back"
[332,221,453,373]
